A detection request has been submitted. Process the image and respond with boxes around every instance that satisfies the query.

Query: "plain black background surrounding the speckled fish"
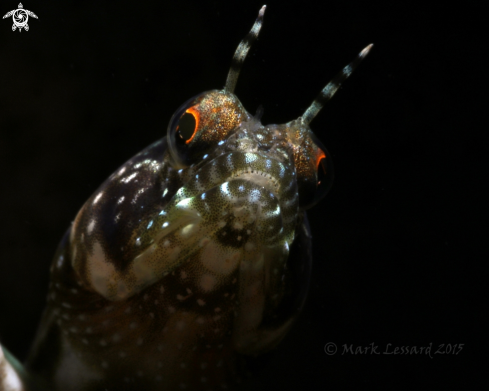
[0,0,489,390]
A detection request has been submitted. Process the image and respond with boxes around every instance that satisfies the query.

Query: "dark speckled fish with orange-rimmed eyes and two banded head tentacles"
[0,7,370,391]
